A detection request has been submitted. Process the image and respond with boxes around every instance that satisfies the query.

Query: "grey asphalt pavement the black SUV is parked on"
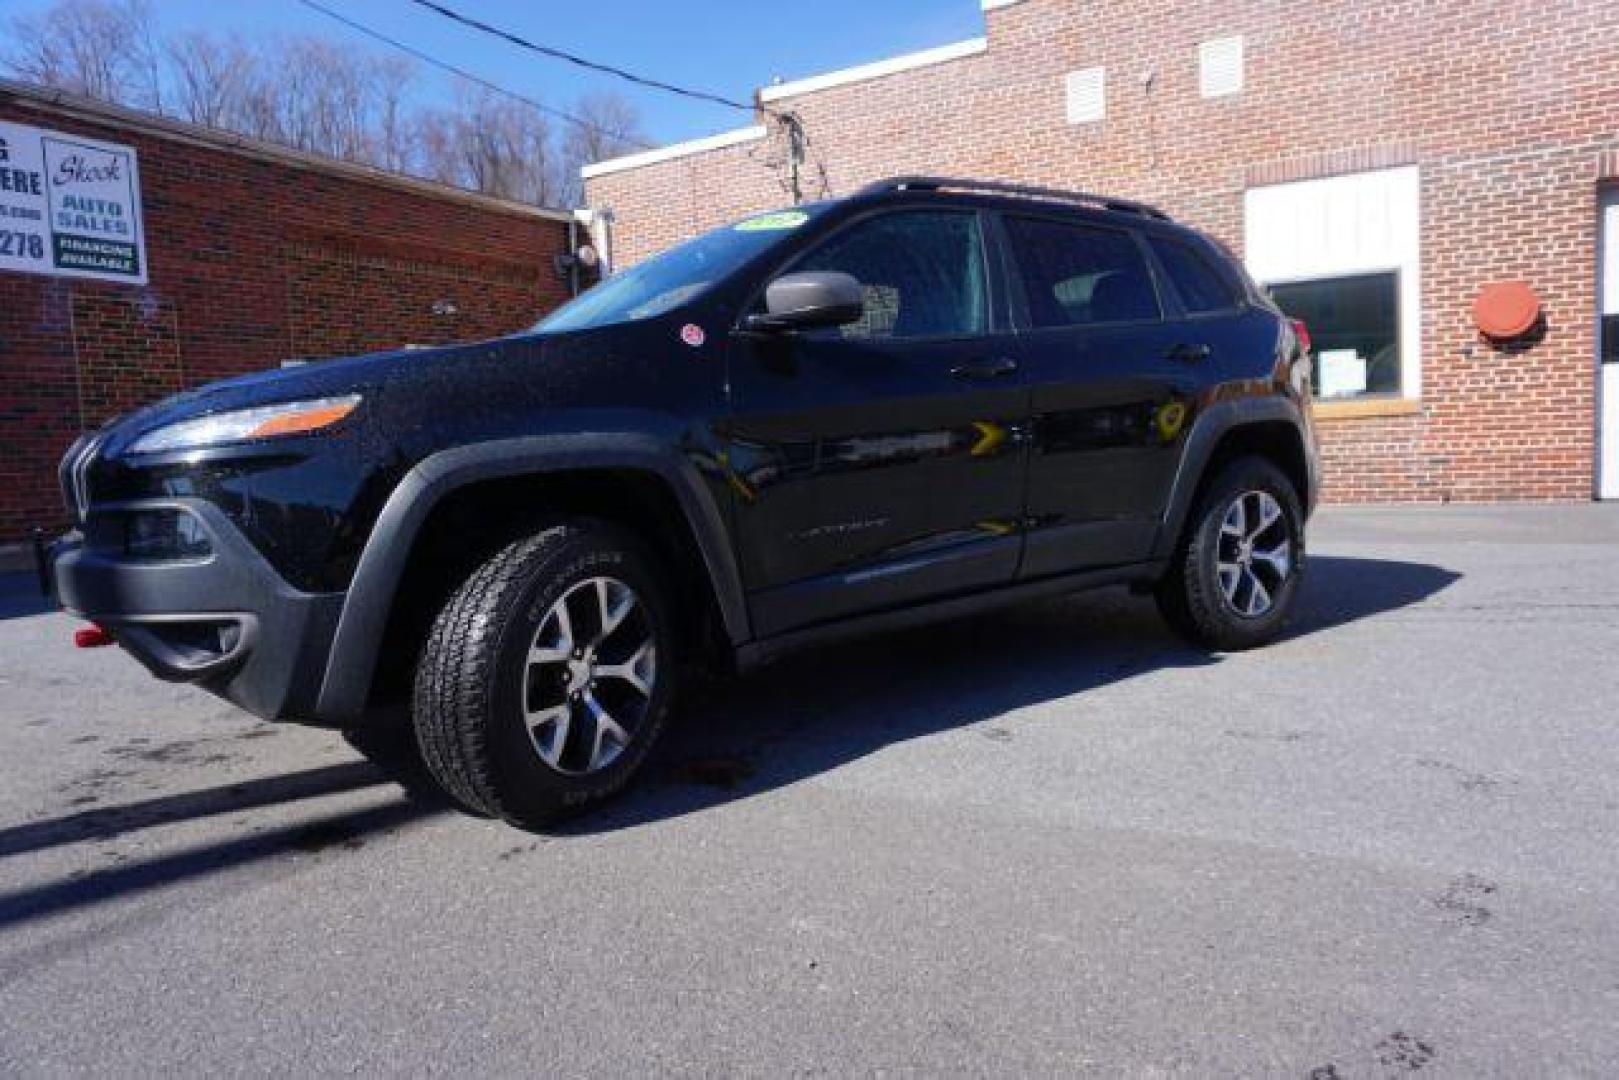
[0,505,1619,1078]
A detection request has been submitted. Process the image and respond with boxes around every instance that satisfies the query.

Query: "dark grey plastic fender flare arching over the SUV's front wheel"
[314,432,750,724]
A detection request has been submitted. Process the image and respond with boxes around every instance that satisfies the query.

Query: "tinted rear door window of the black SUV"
[1007,217,1161,327]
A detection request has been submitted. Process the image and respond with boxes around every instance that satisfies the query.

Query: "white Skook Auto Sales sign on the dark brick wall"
[0,121,146,285]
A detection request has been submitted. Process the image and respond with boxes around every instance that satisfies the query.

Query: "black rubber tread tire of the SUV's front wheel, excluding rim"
[411,520,677,827]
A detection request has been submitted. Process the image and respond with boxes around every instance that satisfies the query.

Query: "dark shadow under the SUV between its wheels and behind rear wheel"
[555,555,1460,836]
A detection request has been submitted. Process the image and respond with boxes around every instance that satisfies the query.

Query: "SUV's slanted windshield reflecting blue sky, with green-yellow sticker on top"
[534,207,816,330]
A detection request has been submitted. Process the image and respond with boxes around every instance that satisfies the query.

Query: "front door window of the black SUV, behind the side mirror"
[793,210,989,338]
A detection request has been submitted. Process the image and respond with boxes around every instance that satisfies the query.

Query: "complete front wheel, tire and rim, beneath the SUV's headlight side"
[411,521,674,826]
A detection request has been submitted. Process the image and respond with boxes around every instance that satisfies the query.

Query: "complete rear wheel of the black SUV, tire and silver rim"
[1158,457,1305,651]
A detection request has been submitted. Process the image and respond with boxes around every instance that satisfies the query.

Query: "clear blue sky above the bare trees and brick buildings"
[0,0,983,142]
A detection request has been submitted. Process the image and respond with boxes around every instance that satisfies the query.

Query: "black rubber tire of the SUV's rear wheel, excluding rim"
[1154,457,1307,653]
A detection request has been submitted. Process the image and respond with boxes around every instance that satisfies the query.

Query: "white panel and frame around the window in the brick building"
[1243,165,1421,402]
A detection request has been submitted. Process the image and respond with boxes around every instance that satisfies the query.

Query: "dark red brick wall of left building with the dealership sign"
[0,91,567,542]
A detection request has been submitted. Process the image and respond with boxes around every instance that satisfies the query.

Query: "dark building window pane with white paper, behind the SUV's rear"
[1271,272,1400,398]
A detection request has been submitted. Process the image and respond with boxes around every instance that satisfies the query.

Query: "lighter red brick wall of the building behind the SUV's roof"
[586,0,1619,500]
